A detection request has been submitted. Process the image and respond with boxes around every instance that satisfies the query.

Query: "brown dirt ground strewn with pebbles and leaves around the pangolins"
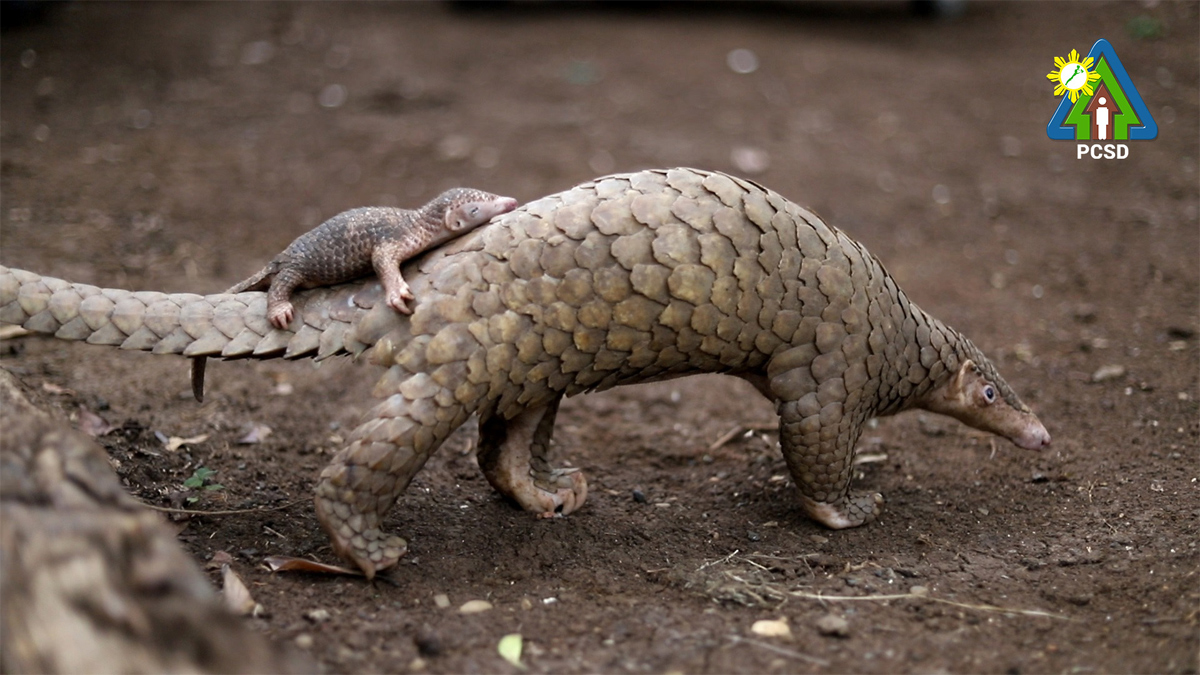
[0,2,1200,673]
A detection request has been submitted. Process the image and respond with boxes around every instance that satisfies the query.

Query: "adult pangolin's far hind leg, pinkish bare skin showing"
[479,396,588,518]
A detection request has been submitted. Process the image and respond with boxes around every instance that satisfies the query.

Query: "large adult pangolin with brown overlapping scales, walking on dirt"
[0,169,1050,577]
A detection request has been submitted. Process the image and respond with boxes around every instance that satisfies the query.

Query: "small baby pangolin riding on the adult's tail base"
[192,187,517,401]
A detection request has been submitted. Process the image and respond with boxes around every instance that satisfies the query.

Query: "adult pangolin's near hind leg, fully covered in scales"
[316,386,469,579]
